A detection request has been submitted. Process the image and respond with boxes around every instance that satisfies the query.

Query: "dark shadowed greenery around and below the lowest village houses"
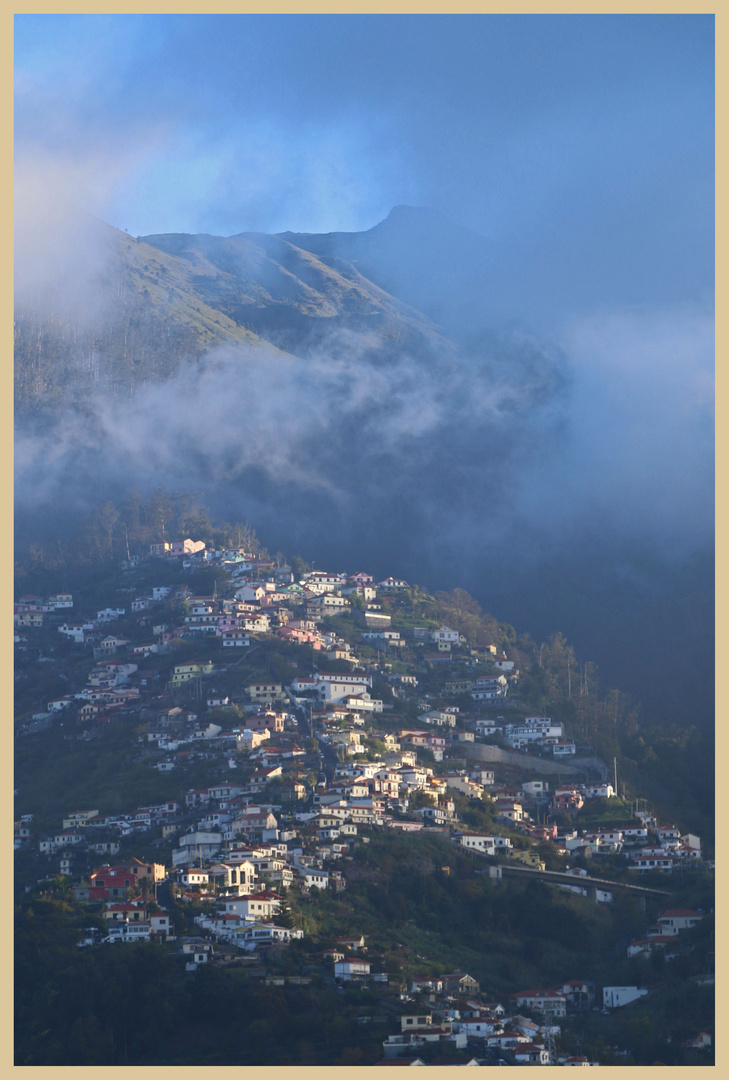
[16,829,714,1065]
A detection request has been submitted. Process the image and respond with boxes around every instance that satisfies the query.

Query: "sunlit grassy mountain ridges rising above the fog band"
[15,211,454,417]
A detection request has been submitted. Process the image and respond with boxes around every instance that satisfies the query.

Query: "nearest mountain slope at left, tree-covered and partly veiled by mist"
[15,215,271,417]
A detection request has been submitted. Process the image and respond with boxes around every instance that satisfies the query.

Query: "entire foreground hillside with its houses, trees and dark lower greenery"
[15,518,714,1065]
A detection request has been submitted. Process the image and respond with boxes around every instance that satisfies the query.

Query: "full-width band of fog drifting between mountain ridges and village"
[15,282,713,575]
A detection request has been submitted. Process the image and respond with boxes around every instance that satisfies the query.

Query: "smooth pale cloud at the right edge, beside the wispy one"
[509,308,714,554]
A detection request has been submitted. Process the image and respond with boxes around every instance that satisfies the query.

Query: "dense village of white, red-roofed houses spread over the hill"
[14,539,713,1065]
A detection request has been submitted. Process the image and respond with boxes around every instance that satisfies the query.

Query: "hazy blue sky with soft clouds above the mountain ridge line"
[15,15,714,313]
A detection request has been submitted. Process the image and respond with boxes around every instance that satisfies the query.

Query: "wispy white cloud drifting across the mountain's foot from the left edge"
[15,332,555,528]
